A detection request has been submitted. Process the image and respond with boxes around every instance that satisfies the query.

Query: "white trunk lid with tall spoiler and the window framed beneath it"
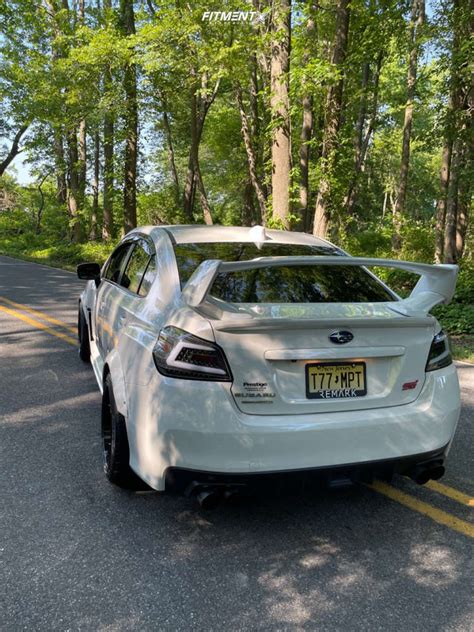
[182,256,458,415]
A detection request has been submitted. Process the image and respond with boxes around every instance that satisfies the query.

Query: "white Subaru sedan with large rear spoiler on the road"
[78,226,460,506]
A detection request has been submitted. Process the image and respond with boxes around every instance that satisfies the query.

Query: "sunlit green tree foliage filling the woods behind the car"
[0,0,474,340]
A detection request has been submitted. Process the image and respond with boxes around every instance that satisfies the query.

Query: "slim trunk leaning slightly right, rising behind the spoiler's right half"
[392,0,425,250]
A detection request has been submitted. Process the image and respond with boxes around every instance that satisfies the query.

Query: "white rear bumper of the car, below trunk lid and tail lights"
[128,366,460,490]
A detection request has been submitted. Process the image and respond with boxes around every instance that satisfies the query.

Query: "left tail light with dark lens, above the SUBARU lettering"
[153,327,232,382]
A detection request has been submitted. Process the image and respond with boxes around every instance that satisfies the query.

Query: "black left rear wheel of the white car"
[102,374,146,490]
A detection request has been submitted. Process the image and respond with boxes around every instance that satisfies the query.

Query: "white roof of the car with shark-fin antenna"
[137,224,333,246]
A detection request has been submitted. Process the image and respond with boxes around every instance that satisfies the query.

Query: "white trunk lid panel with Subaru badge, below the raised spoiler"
[211,304,435,415]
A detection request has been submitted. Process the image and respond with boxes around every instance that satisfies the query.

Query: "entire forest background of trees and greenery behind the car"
[0,0,474,360]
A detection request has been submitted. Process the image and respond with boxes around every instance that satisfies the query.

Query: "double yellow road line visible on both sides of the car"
[0,296,474,538]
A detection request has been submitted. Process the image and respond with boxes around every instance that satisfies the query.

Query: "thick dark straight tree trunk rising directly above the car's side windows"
[120,0,138,233]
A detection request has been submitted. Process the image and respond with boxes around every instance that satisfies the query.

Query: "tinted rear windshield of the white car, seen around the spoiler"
[175,242,394,303]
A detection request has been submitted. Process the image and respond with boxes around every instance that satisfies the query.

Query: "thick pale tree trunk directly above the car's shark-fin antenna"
[270,0,291,228]
